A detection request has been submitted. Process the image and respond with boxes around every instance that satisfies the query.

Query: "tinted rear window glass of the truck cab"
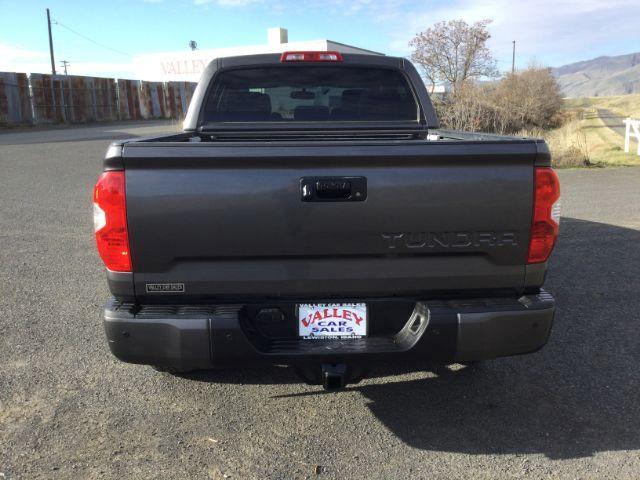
[203,65,418,123]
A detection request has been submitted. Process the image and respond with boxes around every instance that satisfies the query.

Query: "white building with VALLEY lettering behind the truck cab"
[133,27,383,82]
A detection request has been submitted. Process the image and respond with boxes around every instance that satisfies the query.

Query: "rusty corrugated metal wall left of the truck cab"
[0,72,196,126]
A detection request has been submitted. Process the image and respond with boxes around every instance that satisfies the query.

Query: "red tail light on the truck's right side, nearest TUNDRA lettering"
[527,167,560,263]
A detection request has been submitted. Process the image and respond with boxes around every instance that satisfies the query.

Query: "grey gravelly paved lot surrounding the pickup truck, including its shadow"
[0,126,640,479]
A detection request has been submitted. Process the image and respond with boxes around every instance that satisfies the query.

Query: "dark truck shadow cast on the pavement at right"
[191,218,640,459]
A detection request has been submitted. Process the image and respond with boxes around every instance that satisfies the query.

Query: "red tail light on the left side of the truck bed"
[93,172,131,272]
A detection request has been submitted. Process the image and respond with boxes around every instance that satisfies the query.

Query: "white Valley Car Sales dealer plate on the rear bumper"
[298,303,367,340]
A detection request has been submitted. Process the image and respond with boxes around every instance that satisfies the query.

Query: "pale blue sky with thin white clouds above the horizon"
[0,0,640,76]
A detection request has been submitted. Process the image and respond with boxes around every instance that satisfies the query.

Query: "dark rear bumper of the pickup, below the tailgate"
[103,291,555,369]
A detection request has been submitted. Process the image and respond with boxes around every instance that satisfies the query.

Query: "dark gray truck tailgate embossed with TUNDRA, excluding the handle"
[123,141,536,299]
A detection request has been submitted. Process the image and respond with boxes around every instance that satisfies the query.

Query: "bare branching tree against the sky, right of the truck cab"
[409,20,498,90]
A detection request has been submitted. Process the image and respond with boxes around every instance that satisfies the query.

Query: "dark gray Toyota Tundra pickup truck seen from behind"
[94,52,560,388]
